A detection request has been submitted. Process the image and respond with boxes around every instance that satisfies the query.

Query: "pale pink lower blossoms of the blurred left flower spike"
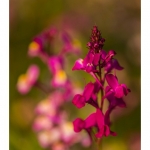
[33,91,90,150]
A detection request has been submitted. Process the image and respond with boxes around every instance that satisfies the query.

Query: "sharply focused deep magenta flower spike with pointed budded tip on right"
[72,26,130,138]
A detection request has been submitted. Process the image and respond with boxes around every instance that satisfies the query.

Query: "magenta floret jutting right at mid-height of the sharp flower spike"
[106,74,130,98]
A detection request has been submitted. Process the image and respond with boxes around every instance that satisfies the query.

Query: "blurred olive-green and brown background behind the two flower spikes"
[9,0,141,150]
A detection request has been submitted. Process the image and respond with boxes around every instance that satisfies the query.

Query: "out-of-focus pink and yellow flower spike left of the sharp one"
[17,28,91,150]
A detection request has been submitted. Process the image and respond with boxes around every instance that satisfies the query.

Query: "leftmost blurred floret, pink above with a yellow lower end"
[17,65,39,94]
